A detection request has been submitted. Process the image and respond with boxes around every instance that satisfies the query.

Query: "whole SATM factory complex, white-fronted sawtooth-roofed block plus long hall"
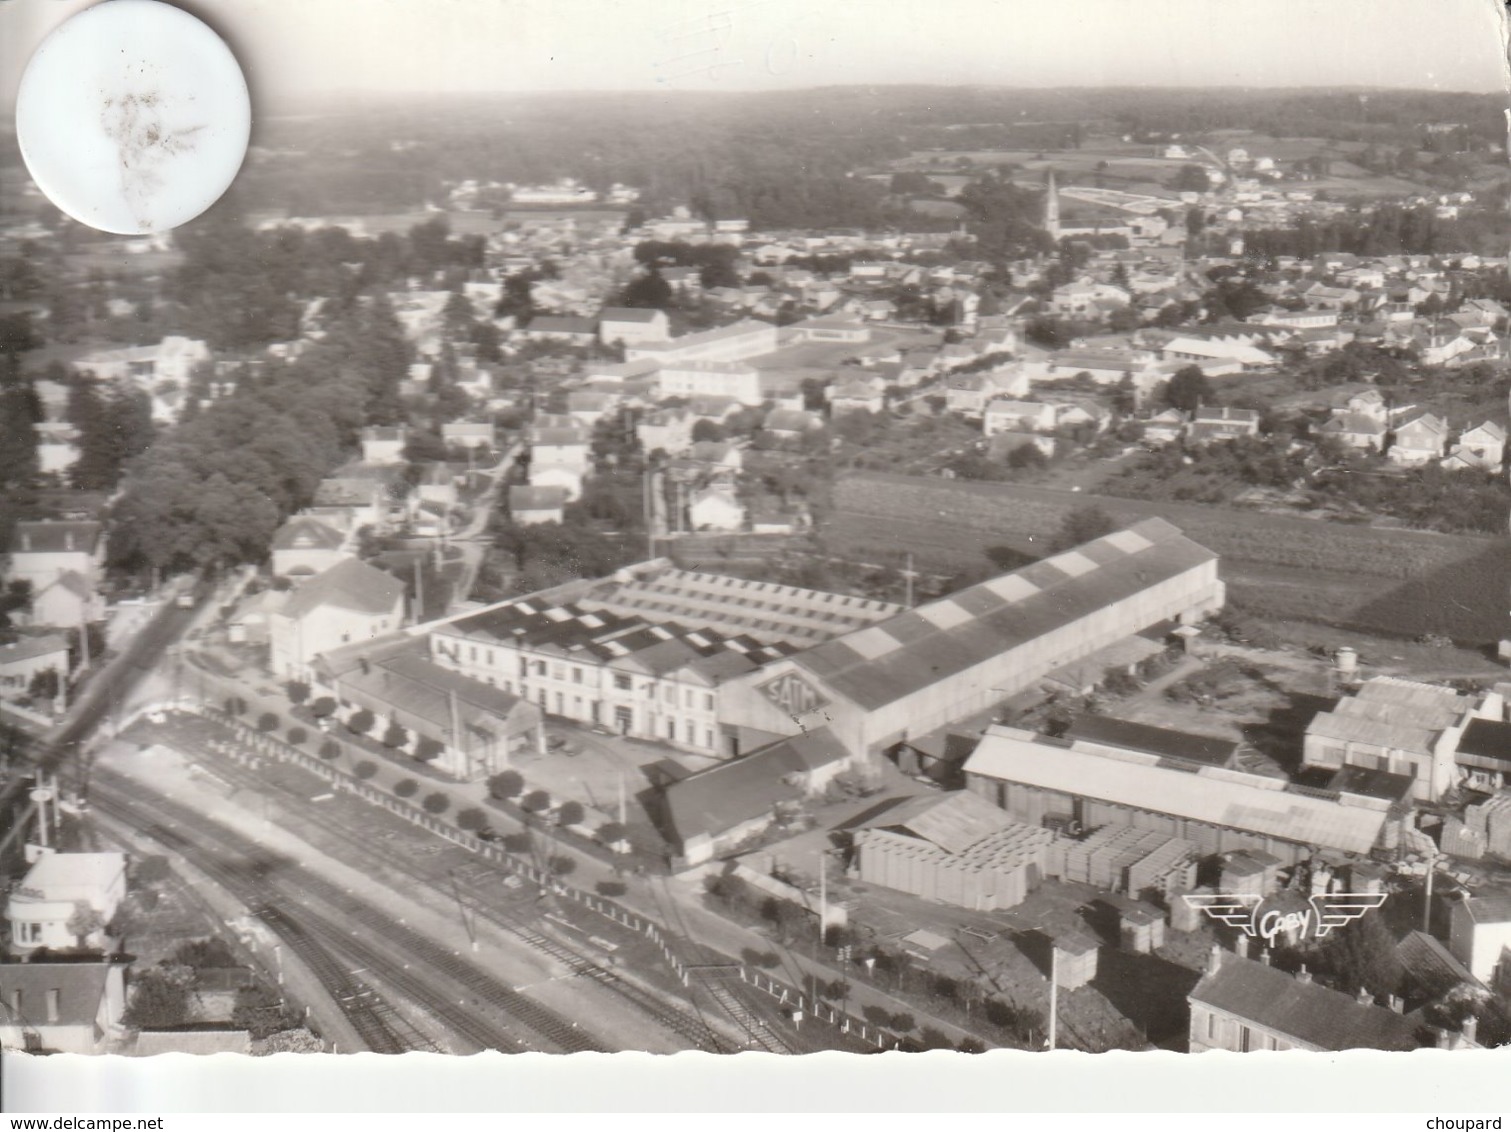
[429,518,1224,757]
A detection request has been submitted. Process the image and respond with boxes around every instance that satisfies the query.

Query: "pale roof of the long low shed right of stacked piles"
[966,727,1386,852]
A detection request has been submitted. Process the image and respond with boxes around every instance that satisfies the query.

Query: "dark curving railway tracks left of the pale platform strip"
[94,771,607,1053]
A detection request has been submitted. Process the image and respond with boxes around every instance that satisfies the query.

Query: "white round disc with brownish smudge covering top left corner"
[15,0,252,236]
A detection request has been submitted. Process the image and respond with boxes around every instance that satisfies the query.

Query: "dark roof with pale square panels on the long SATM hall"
[793,518,1216,710]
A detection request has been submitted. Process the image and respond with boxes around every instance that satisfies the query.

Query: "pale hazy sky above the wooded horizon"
[0,0,1508,106]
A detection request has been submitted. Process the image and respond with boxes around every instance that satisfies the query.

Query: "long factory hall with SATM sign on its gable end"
[718,518,1224,756]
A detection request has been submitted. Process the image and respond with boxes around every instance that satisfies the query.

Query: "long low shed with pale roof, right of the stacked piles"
[964,727,1402,864]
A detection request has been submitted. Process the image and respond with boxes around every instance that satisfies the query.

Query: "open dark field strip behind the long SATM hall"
[822,472,1511,645]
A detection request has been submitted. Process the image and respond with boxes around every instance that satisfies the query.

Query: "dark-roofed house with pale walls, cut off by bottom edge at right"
[1186,946,1435,1053]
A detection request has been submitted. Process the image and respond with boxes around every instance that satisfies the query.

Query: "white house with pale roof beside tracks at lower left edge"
[6,851,125,955]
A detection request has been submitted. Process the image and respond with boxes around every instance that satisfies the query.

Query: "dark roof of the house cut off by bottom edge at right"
[1191,954,1432,1052]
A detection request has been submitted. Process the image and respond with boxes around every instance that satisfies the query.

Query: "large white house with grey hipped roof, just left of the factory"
[267,558,405,680]
